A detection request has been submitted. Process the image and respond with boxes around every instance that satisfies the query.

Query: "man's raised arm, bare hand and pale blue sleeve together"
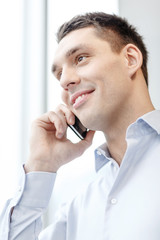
[0,106,93,240]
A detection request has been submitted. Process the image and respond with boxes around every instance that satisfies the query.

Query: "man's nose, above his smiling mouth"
[60,67,80,90]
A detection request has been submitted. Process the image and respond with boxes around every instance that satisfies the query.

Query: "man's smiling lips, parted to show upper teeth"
[70,90,94,108]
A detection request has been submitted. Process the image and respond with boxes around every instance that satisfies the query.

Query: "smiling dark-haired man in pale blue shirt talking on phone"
[0,13,160,240]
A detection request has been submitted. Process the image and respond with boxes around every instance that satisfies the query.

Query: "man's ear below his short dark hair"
[123,43,143,78]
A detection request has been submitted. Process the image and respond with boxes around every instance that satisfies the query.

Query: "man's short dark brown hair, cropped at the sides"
[57,12,148,86]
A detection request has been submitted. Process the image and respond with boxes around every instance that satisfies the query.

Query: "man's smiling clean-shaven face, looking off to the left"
[53,27,129,131]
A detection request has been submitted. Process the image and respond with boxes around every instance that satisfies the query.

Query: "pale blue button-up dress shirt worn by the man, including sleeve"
[0,110,160,240]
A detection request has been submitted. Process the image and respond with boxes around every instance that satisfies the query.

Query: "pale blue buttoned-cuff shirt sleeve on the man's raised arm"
[0,167,64,240]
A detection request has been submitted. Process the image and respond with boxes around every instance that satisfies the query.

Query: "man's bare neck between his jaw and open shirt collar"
[104,79,154,165]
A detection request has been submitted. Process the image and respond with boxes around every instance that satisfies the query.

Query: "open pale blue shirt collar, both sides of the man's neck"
[95,110,160,172]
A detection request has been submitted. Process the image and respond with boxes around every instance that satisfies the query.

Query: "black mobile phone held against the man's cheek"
[68,116,88,140]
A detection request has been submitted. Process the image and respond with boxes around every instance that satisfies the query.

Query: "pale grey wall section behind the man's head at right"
[119,0,160,109]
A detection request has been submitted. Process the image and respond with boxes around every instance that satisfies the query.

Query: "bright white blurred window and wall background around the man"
[0,0,160,227]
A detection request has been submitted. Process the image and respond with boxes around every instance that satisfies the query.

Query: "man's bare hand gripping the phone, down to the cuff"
[25,105,94,173]
